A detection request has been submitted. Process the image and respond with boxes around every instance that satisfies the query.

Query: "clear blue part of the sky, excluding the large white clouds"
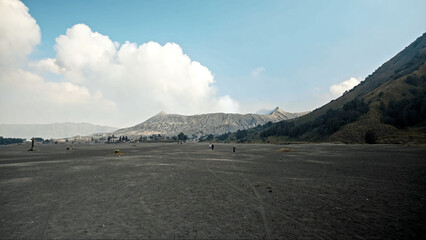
[1,0,426,126]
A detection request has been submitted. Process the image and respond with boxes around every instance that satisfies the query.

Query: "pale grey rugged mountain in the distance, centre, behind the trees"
[114,107,303,137]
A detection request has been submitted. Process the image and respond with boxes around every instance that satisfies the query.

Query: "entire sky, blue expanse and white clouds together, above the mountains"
[0,0,426,127]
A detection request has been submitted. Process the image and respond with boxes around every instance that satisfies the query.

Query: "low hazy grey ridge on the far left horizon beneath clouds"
[0,123,118,140]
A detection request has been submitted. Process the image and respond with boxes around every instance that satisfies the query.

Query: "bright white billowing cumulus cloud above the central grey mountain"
[50,24,238,124]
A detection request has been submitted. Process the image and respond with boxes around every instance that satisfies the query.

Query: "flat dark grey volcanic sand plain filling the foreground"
[0,143,426,239]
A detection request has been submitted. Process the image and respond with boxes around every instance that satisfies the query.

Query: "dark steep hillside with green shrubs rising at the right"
[219,33,426,143]
